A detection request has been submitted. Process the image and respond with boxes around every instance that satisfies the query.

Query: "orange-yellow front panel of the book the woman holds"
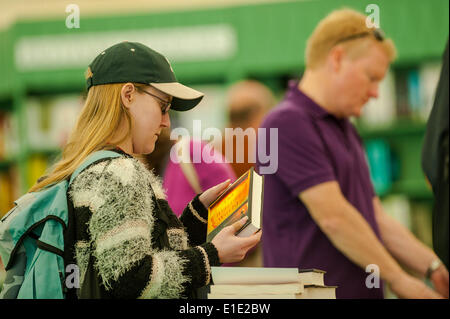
[207,174,250,234]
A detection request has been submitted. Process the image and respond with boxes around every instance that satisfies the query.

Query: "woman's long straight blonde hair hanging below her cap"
[29,83,143,192]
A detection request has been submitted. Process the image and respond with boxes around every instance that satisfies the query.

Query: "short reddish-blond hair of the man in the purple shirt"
[305,9,397,69]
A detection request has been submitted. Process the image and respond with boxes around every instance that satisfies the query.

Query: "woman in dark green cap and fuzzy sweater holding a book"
[27,42,261,298]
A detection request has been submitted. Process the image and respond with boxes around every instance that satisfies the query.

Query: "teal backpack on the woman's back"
[0,151,121,299]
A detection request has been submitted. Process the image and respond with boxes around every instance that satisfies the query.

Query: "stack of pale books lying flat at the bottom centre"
[208,267,337,299]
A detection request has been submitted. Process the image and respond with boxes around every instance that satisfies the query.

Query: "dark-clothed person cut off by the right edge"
[422,40,449,274]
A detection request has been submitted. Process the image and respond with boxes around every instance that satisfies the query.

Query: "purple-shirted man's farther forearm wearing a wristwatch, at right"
[373,197,448,298]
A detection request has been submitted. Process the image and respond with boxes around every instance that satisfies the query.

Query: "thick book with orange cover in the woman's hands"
[206,168,264,242]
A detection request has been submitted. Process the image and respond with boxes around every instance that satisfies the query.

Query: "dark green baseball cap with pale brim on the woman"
[86,41,204,111]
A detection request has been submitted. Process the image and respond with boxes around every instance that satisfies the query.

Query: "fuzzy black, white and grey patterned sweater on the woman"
[68,152,220,298]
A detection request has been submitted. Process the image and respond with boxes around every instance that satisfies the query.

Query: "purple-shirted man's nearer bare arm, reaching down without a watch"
[299,181,441,298]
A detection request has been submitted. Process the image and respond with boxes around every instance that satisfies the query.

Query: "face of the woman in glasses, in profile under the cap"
[122,83,172,154]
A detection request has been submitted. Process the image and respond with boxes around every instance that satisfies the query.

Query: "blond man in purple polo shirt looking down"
[257,9,448,298]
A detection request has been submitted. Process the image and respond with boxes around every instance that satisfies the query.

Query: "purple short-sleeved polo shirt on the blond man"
[257,82,383,298]
